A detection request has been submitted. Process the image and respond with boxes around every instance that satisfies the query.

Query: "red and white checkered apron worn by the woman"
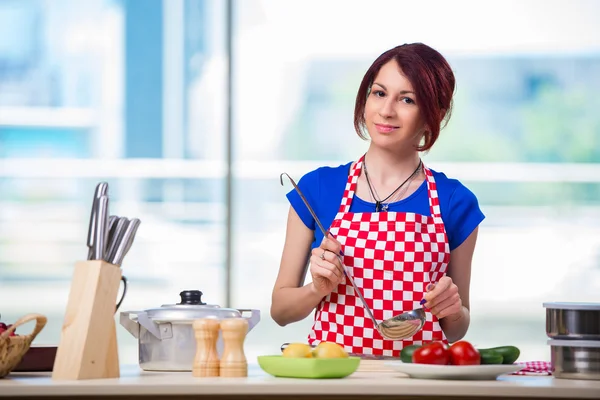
[308,156,450,357]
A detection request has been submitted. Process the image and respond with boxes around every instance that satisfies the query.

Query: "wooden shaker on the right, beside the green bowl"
[220,318,248,377]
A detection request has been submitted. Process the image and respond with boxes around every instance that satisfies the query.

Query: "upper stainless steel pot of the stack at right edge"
[543,303,600,340]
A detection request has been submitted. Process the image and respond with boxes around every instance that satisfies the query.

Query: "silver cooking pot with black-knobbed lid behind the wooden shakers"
[120,290,260,371]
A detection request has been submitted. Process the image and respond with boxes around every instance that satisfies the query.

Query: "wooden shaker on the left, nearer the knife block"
[192,318,219,377]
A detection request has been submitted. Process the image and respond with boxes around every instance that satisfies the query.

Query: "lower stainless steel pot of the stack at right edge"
[548,340,600,380]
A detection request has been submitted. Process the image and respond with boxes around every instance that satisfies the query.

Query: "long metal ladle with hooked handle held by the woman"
[279,172,425,340]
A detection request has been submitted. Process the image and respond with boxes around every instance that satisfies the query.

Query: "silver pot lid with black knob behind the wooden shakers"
[144,290,241,322]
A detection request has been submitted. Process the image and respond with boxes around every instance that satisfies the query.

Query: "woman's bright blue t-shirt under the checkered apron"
[287,162,485,250]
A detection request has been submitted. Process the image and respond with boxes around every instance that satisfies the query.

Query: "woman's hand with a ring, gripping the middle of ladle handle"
[310,235,344,297]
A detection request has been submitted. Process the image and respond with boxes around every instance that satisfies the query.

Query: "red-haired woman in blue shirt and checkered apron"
[271,43,484,357]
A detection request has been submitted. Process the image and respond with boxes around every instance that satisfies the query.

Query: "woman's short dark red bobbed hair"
[354,43,455,151]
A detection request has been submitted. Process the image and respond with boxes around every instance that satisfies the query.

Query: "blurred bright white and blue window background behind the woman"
[0,0,600,364]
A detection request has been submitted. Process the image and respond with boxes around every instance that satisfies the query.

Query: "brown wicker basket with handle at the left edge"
[0,314,47,378]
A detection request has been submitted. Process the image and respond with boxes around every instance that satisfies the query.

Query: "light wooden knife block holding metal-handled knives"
[52,260,121,380]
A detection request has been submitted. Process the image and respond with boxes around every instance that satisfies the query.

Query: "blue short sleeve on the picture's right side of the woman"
[446,183,485,250]
